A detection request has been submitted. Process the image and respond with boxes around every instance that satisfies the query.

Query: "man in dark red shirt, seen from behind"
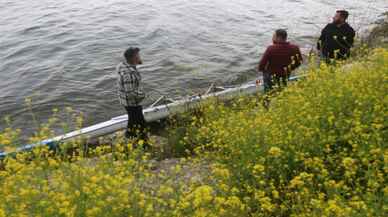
[258,29,303,91]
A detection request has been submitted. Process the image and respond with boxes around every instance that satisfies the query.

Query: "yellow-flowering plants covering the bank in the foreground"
[0,46,388,217]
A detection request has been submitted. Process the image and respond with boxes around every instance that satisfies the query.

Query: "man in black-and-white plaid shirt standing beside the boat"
[117,47,148,143]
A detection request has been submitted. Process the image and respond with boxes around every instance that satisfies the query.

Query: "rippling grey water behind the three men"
[0,0,388,136]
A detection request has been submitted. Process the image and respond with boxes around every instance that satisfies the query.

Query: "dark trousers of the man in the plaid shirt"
[125,106,148,142]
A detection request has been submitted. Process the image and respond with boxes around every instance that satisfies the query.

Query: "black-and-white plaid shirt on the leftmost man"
[116,62,145,107]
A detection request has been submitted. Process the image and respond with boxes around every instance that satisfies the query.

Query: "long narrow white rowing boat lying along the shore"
[0,76,301,159]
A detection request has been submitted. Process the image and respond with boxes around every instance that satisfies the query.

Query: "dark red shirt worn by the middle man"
[259,42,303,76]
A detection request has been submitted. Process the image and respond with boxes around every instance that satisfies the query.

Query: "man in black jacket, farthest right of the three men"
[317,10,356,62]
